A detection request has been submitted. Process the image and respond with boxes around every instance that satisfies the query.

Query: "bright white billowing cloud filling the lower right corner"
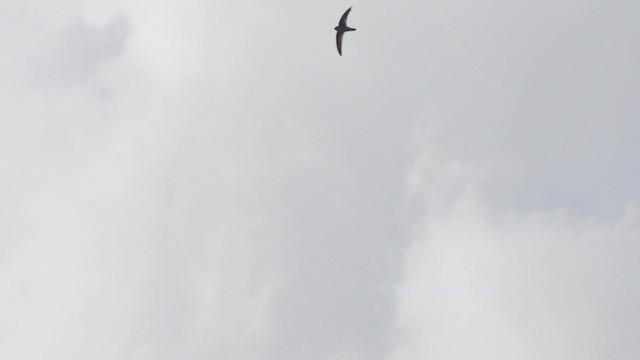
[389,170,640,359]
